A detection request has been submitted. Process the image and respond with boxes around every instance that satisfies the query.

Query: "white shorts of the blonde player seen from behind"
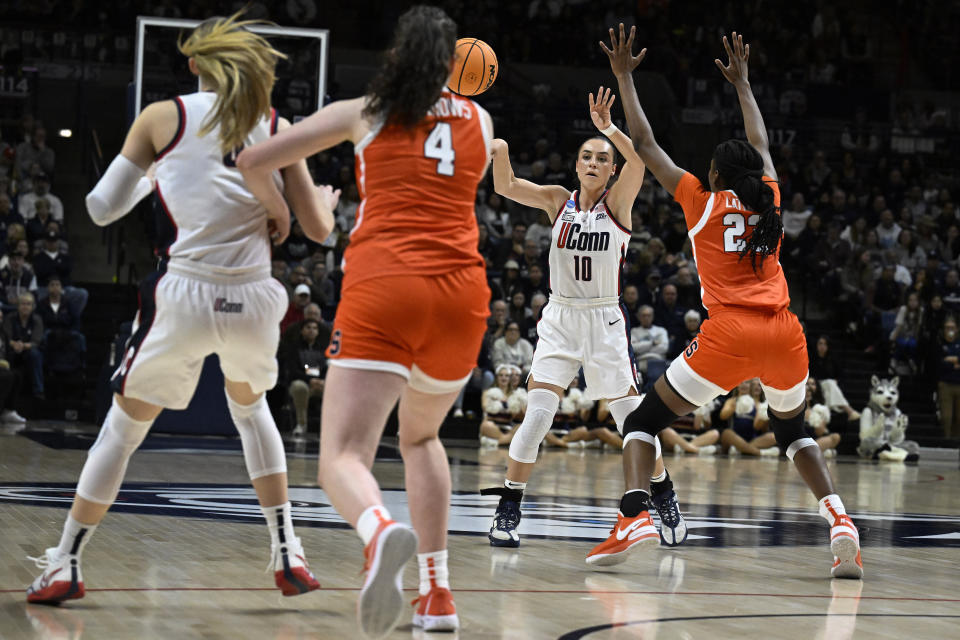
[111,265,288,409]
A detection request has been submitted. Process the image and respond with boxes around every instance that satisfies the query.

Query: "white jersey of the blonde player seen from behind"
[156,91,282,272]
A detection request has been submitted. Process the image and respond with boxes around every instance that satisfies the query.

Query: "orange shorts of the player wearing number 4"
[327,268,490,393]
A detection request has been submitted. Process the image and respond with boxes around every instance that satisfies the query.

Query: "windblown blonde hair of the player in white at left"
[177,11,286,153]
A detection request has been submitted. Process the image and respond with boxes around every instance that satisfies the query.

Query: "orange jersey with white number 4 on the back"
[343,91,489,287]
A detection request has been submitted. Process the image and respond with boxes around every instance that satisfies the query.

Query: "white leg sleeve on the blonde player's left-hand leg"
[77,400,153,504]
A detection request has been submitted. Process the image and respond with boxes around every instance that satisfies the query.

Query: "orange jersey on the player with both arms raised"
[673,172,790,313]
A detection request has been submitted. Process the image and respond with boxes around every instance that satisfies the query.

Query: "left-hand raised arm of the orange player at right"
[600,23,685,195]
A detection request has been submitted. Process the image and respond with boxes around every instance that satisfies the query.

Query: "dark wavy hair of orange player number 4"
[363,5,457,129]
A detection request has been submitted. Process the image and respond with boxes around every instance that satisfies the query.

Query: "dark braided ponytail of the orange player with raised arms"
[713,140,783,273]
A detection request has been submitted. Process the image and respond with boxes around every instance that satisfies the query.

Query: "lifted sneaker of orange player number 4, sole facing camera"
[357,520,417,638]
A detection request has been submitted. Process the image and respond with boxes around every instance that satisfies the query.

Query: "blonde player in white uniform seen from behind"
[27,14,338,603]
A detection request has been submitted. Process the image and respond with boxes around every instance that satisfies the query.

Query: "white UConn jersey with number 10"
[550,191,630,298]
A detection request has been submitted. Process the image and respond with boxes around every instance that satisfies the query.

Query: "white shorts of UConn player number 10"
[530,296,640,400]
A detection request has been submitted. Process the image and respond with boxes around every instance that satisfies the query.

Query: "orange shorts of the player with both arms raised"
[666,307,809,411]
